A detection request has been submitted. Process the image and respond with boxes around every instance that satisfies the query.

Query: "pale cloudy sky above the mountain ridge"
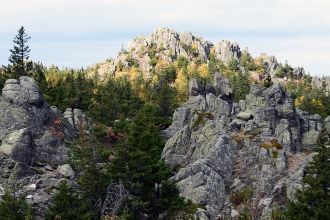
[0,0,330,75]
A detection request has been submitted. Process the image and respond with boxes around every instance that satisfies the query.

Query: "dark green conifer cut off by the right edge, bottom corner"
[286,133,330,220]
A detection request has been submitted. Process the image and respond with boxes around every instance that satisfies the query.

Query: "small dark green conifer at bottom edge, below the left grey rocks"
[45,181,83,220]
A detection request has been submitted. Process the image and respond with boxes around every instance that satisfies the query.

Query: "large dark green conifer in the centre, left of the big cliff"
[110,105,188,218]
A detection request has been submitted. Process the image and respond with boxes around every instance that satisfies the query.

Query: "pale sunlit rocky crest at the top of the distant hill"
[89,28,241,80]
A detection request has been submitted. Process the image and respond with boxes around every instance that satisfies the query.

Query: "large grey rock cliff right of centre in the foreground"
[162,74,322,219]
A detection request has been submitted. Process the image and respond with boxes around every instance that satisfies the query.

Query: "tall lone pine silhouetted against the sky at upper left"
[6,26,32,78]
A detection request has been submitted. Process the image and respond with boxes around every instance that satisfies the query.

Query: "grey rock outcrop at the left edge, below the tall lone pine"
[0,76,87,219]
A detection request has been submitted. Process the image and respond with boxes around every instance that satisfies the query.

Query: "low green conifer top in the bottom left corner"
[0,189,34,220]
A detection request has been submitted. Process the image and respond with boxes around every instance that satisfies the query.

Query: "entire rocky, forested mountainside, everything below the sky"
[0,27,330,220]
